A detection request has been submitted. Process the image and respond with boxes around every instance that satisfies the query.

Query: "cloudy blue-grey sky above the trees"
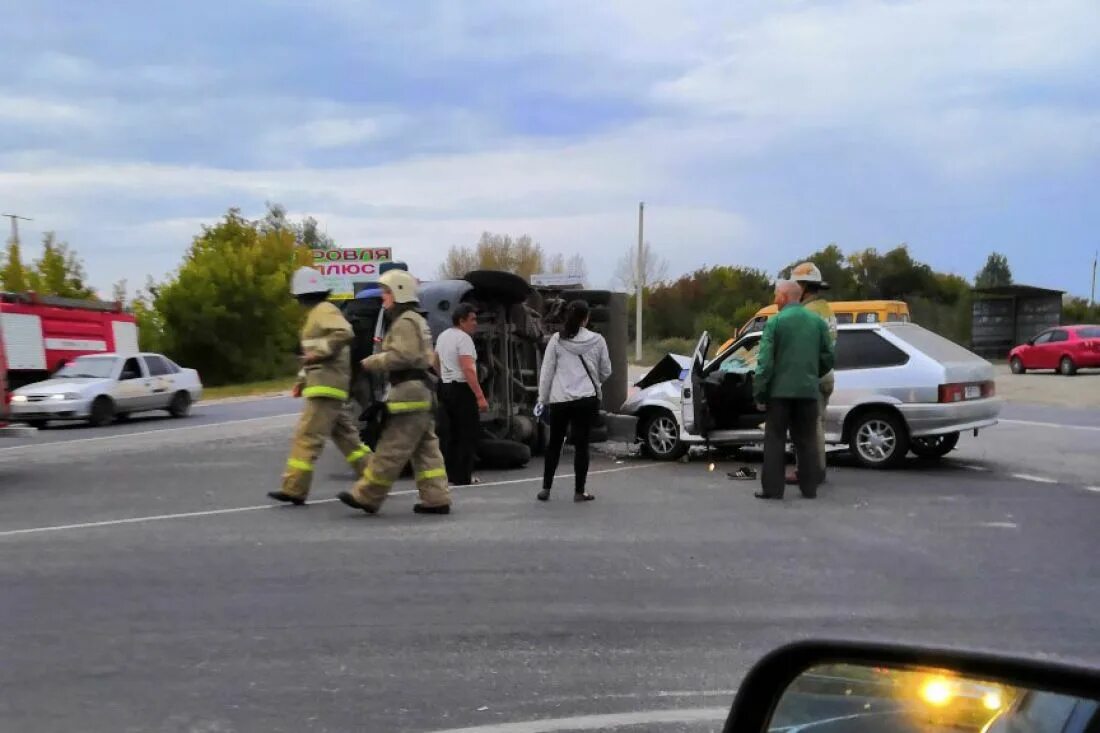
[0,0,1100,294]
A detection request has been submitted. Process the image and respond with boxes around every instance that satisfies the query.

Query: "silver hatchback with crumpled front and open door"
[620,324,1002,468]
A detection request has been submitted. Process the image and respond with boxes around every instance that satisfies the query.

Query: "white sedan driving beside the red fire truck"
[10,353,202,427]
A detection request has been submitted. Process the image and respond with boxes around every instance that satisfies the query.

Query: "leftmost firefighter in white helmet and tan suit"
[267,267,371,505]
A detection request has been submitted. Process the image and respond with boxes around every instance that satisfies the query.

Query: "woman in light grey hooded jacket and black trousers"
[535,300,612,502]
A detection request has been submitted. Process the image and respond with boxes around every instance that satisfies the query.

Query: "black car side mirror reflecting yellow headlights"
[723,642,1100,733]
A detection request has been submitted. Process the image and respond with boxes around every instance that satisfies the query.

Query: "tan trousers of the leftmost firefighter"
[283,397,371,499]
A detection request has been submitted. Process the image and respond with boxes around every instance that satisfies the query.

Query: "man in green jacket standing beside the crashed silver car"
[752,280,835,499]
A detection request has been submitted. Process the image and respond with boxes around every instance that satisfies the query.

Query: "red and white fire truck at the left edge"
[0,293,138,435]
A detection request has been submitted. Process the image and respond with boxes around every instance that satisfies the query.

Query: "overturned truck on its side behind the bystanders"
[341,271,627,468]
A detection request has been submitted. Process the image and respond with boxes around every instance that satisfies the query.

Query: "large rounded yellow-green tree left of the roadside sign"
[144,209,310,385]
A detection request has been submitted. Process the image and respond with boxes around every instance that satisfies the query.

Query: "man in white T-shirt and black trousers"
[436,303,488,486]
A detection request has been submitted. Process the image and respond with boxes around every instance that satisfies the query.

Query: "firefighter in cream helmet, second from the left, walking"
[339,270,451,514]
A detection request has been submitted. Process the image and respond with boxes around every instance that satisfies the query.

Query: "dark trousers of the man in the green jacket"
[760,397,821,496]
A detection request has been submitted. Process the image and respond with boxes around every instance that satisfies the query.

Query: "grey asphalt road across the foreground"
[0,400,1100,733]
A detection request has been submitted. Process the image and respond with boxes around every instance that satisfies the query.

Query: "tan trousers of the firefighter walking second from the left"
[352,412,451,508]
